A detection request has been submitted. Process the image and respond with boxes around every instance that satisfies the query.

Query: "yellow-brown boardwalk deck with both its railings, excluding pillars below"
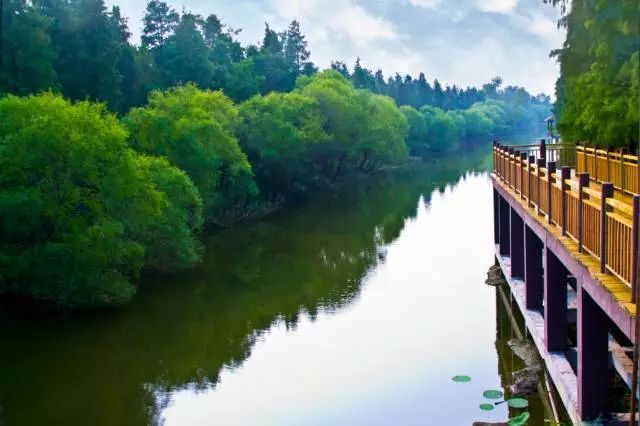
[494,145,640,315]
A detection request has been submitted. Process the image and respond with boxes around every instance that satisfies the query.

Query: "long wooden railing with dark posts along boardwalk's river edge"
[493,143,640,303]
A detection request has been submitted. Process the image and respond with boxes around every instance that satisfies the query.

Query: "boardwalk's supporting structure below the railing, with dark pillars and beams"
[493,176,635,424]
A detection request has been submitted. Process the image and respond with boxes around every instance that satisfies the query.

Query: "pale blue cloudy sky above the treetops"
[109,0,565,96]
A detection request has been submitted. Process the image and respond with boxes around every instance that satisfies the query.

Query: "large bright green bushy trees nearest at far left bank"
[0,94,198,307]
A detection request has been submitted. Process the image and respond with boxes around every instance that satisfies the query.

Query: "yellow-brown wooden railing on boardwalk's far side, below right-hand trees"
[575,146,640,195]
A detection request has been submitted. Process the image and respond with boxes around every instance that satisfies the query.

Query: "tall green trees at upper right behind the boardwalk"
[551,0,640,150]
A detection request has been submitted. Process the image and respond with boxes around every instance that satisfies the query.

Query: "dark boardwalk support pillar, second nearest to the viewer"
[544,249,569,352]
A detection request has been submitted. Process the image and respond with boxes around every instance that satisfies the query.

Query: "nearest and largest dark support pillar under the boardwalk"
[578,283,609,421]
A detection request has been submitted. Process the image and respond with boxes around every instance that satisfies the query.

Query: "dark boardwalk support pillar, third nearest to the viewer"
[524,225,544,310]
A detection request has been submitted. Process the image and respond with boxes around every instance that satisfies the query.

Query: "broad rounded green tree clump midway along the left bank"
[236,71,408,195]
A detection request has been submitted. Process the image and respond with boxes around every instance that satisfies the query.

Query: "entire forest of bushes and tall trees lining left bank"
[0,0,550,308]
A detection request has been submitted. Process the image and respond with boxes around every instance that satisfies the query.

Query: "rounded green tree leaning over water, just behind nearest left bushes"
[124,85,257,222]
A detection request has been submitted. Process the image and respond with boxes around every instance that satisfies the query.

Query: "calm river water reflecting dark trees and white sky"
[0,155,556,426]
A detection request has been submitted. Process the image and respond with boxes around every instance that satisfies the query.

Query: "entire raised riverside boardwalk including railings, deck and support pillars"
[492,142,640,424]
